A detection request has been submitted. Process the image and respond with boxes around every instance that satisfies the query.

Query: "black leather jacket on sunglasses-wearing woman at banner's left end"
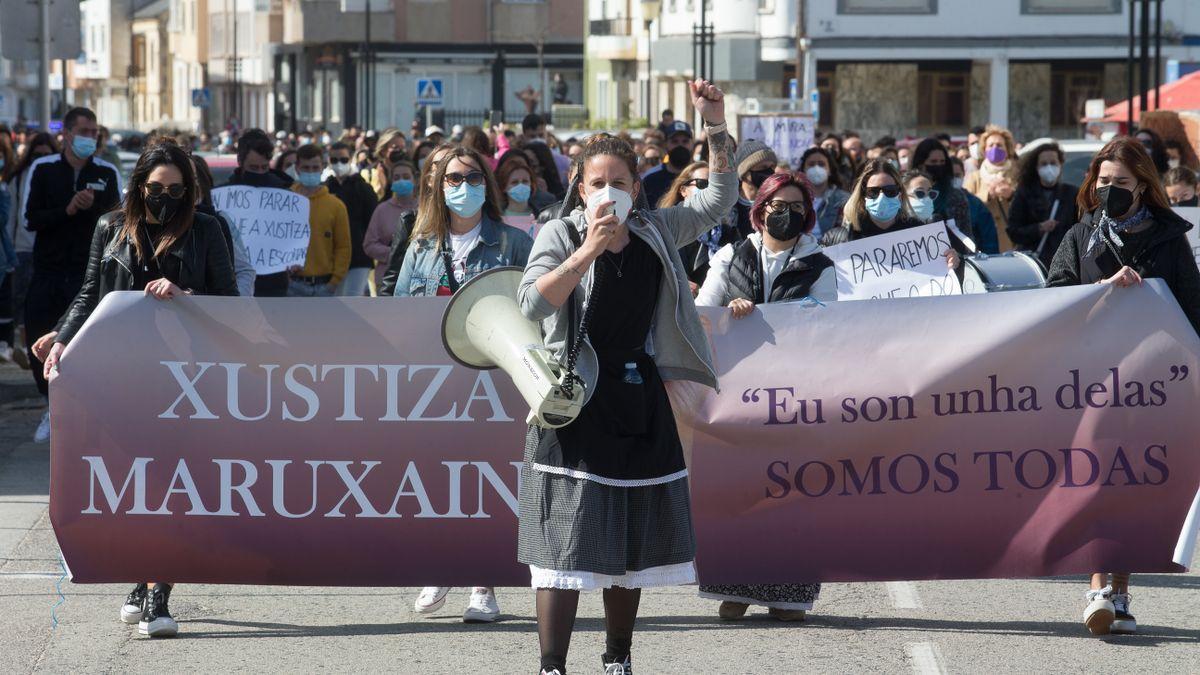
[54,211,238,345]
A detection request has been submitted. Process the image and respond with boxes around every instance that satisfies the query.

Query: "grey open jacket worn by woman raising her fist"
[517,166,738,400]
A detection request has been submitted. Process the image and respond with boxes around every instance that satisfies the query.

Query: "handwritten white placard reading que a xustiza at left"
[212,185,308,274]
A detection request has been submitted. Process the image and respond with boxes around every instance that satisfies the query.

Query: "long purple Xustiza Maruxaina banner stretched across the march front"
[50,280,1200,586]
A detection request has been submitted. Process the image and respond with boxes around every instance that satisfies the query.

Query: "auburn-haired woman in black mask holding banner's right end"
[1046,132,1200,635]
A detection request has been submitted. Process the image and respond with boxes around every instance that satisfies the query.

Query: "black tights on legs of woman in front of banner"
[538,587,642,673]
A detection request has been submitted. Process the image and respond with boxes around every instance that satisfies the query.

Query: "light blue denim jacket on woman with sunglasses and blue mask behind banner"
[396,215,533,298]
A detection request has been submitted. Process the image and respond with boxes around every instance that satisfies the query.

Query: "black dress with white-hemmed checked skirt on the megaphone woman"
[517,235,696,590]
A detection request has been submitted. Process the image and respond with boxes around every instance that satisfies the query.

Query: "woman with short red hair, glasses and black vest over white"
[696,168,838,314]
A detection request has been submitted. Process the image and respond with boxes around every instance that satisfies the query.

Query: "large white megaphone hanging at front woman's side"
[442,267,584,429]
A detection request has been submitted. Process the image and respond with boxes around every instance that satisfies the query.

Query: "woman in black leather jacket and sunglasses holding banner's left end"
[35,141,238,638]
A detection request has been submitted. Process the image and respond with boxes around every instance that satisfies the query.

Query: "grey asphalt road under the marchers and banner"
[0,368,1200,674]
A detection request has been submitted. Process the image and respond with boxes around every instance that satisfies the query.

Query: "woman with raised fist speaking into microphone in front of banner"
[517,80,738,674]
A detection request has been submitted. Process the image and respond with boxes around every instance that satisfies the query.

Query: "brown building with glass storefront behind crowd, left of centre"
[274,0,583,130]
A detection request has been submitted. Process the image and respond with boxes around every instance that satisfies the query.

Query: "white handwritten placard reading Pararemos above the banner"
[824,222,962,300]
